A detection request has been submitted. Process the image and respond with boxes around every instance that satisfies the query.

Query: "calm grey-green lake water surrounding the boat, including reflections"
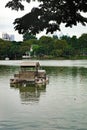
[0,60,87,130]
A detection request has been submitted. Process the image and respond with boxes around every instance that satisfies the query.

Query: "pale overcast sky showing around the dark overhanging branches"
[0,0,87,41]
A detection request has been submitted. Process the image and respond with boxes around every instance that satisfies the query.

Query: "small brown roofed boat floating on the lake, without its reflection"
[10,62,48,85]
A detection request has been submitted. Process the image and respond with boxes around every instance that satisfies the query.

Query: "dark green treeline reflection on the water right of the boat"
[45,67,87,77]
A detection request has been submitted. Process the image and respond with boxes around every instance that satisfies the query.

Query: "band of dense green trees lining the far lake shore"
[0,34,87,59]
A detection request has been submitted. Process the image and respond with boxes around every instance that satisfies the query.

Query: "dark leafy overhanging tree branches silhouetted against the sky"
[6,0,87,34]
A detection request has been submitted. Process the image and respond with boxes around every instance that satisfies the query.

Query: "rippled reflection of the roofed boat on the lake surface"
[10,83,46,104]
